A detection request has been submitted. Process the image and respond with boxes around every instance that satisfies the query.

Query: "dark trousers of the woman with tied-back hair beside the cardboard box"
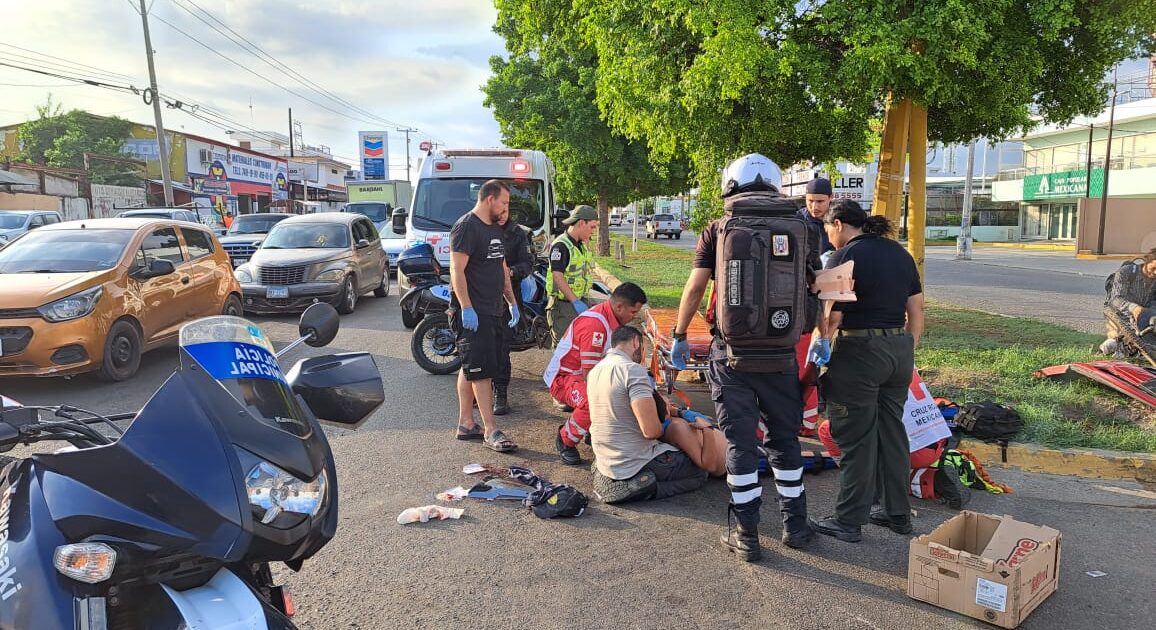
[822,334,916,525]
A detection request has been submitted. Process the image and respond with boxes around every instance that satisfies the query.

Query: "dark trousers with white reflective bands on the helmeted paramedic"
[707,358,807,531]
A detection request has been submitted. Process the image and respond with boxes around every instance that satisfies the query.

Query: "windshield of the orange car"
[0,229,135,274]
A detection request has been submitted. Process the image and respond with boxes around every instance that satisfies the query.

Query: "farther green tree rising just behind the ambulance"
[482,0,689,255]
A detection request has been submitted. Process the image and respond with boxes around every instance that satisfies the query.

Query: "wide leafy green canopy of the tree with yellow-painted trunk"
[575,0,1156,220]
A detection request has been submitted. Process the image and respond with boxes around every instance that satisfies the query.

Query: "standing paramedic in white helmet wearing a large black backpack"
[670,154,829,562]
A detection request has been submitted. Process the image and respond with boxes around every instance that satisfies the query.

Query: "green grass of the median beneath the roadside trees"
[598,231,1156,453]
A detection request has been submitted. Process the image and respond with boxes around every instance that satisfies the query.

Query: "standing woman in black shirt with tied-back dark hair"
[812,200,924,542]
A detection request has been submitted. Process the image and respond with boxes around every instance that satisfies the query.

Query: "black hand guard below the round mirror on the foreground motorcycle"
[286,353,385,429]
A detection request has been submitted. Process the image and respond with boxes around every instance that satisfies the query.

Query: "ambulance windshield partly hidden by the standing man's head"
[413,177,546,231]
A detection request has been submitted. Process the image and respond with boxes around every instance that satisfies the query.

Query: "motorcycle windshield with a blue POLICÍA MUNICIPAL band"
[180,316,312,438]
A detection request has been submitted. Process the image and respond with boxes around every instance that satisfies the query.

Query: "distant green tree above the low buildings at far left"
[18,96,141,185]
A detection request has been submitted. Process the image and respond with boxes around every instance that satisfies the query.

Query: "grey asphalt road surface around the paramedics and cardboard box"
[0,287,1156,630]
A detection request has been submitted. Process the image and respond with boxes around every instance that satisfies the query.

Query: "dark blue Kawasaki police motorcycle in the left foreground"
[0,304,385,630]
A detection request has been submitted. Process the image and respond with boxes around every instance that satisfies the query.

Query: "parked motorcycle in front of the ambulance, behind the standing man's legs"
[398,243,550,375]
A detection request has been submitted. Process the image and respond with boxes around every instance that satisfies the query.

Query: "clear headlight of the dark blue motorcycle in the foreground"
[245,461,327,528]
